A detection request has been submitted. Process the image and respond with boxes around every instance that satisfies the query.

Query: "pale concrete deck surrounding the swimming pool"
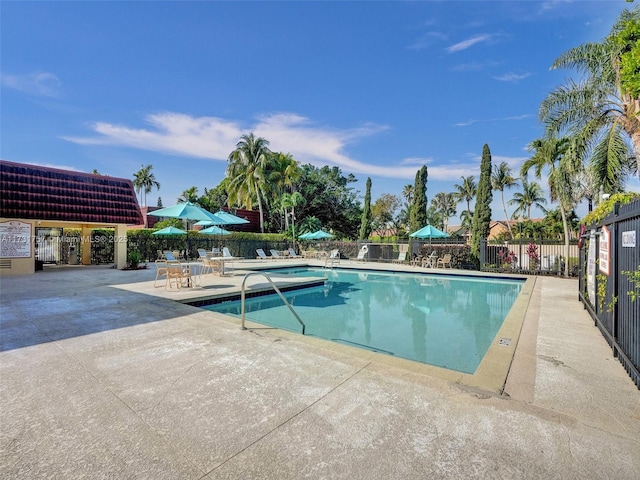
[0,261,640,480]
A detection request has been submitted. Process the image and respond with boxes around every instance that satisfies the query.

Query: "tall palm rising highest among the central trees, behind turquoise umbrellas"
[227,132,271,233]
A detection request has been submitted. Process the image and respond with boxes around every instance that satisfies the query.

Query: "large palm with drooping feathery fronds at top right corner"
[539,8,640,188]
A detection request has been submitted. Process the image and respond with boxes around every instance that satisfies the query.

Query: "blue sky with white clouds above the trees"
[0,0,637,223]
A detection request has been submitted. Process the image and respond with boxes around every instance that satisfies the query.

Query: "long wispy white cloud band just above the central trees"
[63,112,424,178]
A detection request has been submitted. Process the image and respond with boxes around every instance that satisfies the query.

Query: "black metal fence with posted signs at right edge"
[579,201,640,388]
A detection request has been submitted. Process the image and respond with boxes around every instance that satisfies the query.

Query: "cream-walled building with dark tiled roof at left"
[0,160,144,274]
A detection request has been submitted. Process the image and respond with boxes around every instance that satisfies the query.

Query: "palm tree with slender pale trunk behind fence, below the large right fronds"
[520,137,575,276]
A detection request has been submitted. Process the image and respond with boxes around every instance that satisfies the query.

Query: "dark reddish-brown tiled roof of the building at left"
[0,160,143,225]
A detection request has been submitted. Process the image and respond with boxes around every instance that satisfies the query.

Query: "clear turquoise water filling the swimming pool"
[203,268,524,373]
